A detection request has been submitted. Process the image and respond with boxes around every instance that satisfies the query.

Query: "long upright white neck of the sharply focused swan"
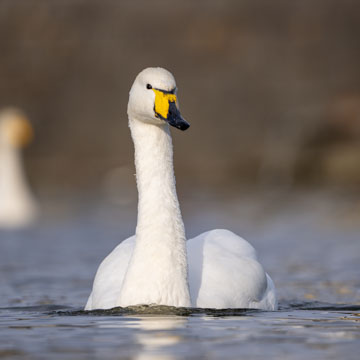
[119,118,191,306]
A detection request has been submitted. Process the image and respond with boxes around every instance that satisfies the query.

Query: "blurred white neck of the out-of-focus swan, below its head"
[0,142,35,227]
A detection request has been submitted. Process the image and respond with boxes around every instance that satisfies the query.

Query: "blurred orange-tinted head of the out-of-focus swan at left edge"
[0,109,34,148]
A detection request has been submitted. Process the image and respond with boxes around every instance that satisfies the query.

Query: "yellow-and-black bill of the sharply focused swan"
[152,89,190,130]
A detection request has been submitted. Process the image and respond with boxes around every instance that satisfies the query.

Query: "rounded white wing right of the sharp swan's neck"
[187,230,278,309]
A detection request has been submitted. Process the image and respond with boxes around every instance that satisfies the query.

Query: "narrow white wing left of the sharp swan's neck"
[85,235,135,310]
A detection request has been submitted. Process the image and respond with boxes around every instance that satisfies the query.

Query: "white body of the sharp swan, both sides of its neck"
[85,230,276,310]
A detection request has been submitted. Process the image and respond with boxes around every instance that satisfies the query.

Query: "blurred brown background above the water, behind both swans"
[0,0,360,194]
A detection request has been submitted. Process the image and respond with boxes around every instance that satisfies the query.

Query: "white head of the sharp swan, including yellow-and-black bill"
[128,67,190,130]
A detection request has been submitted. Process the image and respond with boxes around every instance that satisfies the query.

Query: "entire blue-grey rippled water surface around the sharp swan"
[0,192,360,359]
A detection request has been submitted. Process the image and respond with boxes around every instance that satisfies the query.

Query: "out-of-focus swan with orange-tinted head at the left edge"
[0,108,38,228]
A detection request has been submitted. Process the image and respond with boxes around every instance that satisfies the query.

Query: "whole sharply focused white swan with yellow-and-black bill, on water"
[85,68,277,310]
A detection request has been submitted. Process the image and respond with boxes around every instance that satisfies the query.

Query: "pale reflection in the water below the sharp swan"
[98,315,188,360]
